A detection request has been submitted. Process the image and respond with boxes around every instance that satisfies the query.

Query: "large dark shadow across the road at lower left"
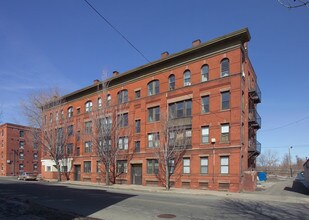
[0,182,135,216]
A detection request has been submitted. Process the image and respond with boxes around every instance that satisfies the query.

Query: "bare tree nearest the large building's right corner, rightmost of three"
[154,109,191,190]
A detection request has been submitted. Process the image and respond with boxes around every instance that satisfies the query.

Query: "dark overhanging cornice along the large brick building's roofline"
[61,27,251,100]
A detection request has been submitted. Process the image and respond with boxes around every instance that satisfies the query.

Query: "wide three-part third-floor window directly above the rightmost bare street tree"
[169,100,192,119]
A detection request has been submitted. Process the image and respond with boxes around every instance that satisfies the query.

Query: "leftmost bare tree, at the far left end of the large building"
[22,89,73,181]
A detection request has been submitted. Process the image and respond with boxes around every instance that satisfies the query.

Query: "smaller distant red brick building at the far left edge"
[0,123,41,176]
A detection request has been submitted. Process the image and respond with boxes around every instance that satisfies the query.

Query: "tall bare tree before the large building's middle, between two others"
[91,80,134,185]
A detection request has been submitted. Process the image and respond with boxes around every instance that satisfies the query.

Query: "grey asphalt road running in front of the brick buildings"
[0,178,309,220]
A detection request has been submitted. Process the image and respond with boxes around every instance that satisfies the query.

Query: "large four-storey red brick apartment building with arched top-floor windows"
[42,28,261,191]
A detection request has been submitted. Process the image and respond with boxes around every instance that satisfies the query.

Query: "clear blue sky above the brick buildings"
[0,0,309,162]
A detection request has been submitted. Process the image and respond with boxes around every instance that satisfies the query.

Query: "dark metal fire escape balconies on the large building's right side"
[248,83,261,168]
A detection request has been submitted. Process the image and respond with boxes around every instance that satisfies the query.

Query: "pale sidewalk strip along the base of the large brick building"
[48,181,309,204]
